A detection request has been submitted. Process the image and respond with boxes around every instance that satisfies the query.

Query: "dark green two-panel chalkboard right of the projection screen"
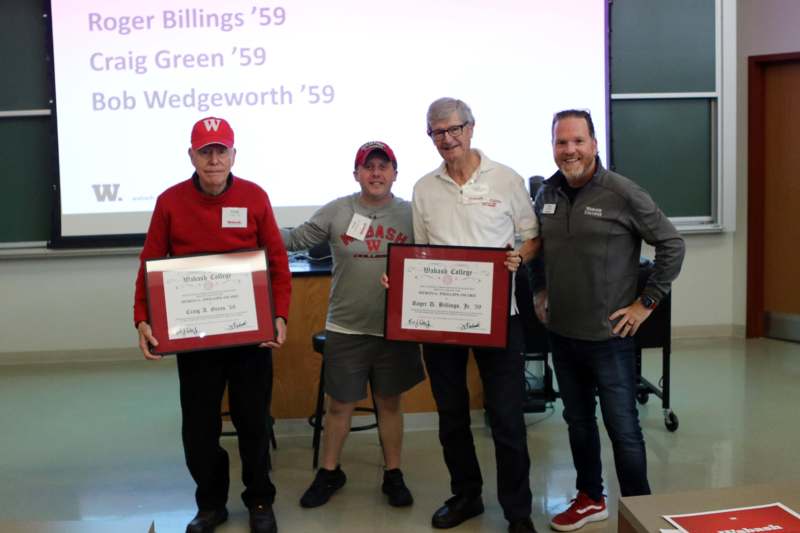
[609,0,717,221]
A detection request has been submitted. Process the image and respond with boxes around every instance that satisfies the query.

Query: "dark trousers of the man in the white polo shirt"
[422,316,532,521]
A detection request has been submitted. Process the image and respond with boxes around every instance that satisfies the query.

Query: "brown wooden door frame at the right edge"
[746,52,800,338]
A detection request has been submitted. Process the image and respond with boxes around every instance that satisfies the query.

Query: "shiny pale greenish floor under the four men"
[0,339,800,533]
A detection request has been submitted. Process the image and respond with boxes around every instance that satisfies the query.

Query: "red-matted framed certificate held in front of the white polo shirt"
[384,243,511,348]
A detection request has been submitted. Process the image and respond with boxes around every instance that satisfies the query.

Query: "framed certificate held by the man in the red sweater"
[145,249,275,354]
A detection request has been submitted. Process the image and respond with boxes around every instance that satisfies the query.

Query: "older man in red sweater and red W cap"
[134,117,291,533]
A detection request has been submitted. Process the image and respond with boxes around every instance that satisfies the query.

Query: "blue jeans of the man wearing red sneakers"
[550,333,650,500]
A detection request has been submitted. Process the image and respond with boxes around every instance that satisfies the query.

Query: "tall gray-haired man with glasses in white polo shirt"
[413,98,540,532]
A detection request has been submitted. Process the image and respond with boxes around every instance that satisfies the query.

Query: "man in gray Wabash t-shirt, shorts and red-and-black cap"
[282,141,425,507]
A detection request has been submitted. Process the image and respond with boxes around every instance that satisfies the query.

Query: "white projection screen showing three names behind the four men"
[50,0,608,237]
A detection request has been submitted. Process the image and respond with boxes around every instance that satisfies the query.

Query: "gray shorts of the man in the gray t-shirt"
[323,331,425,403]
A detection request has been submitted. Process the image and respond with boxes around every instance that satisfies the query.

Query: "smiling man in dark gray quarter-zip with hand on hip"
[533,110,684,531]
